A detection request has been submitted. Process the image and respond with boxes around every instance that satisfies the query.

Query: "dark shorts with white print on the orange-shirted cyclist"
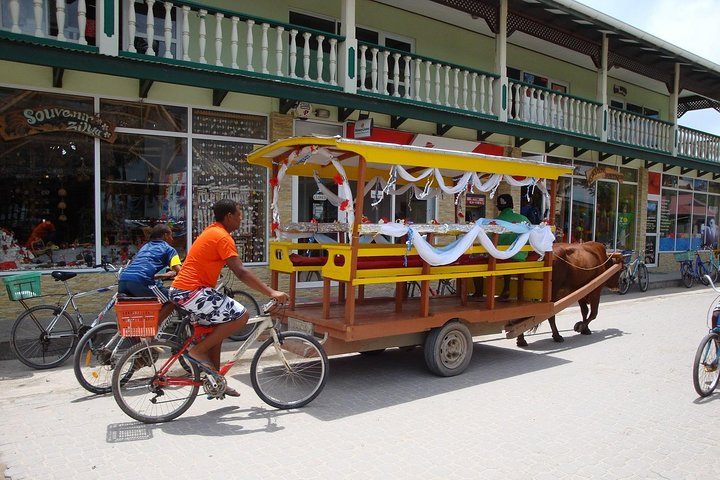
[170,287,247,325]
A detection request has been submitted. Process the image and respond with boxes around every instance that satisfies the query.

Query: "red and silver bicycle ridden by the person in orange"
[112,300,329,423]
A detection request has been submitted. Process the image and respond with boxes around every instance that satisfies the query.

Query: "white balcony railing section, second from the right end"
[608,108,673,153]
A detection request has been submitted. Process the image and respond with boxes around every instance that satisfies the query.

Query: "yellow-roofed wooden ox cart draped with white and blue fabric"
[248,137,620,376]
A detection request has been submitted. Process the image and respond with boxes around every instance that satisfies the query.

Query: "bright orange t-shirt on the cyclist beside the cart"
[172,222,238,290]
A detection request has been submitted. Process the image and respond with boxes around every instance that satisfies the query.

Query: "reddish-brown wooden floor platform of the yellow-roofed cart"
[286,296,553,341]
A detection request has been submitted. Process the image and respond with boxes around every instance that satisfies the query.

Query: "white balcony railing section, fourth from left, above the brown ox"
[508,80,602,137]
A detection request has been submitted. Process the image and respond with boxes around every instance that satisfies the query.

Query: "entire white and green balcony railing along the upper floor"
[0,0,720,163]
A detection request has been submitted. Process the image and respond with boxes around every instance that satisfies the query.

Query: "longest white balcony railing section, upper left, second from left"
[121,0,343,86]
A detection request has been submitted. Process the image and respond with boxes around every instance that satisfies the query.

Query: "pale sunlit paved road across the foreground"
[0,289,720,480]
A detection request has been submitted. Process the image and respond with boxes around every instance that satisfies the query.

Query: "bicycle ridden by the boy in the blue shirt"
[73,286,192,395]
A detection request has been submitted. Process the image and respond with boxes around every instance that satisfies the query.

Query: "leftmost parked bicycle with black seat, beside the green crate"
[10,263,120,370]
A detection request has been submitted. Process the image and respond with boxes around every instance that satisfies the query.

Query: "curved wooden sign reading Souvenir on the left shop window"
[0,107,117,143]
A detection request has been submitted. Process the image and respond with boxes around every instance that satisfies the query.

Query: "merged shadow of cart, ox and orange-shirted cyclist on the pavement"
[107,329,623,436]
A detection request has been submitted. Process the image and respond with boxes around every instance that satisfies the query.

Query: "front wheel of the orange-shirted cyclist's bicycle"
[250,332,330,409]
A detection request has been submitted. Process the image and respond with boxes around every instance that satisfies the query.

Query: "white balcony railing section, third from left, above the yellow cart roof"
[358,43,498,116]
